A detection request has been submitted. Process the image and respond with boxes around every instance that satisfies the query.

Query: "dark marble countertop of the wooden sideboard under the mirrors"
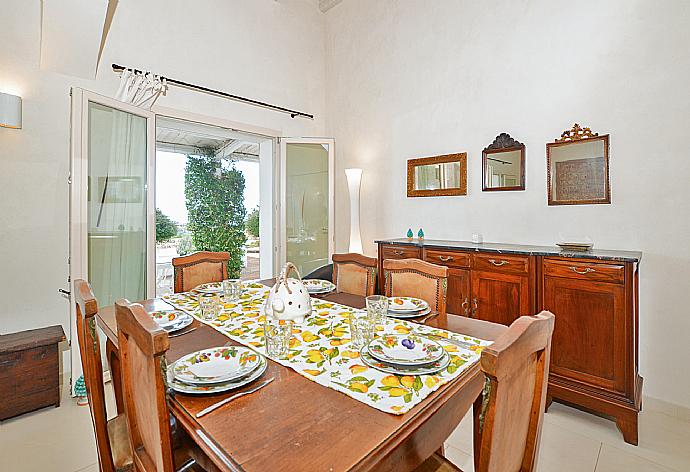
[375,238,642,262]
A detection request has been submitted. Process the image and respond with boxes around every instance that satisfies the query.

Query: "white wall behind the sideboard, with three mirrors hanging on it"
[326,0,690,407]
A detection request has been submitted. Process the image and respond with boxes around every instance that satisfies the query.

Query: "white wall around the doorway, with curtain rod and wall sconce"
[0,0,325,369]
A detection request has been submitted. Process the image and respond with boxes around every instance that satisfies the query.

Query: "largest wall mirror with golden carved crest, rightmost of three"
[546,123,611,205]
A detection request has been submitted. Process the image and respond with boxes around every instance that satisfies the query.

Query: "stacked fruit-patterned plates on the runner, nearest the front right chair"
[360,334,450,375]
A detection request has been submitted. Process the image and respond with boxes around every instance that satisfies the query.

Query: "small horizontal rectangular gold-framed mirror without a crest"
[407,152,467,197]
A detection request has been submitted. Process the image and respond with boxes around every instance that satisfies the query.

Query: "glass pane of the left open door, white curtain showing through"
[87,102,147,306]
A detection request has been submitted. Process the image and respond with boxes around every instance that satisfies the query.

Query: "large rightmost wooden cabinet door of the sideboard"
[543,276,629,393]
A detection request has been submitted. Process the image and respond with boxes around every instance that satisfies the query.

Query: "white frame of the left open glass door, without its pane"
[69,87,156,388]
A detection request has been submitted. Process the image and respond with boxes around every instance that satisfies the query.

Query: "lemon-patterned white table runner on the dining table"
[163,283,491,414]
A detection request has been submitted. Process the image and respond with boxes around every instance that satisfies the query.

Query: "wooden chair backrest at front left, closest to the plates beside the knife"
[115,300,174,472]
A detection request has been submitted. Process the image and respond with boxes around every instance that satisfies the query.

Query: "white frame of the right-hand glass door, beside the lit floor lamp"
[278,138,335,275]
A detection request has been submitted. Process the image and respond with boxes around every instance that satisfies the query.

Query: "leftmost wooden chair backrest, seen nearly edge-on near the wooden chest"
[74,279,115,472]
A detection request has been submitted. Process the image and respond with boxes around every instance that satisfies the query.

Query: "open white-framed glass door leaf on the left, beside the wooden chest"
[69,88,156,385]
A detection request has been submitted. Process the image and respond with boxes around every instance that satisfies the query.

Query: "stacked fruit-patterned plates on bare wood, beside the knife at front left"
[168,346,268,393]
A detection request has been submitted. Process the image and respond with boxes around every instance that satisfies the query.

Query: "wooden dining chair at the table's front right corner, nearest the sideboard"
[416,311,555,472]
